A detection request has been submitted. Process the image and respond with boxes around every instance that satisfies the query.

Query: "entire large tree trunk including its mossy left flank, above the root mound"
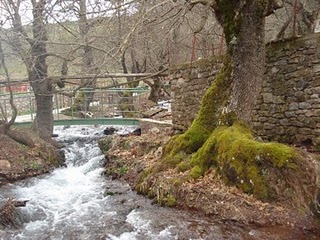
[164,0,279,165]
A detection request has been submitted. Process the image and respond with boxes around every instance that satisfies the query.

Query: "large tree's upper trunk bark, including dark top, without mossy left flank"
[211,0,281,125]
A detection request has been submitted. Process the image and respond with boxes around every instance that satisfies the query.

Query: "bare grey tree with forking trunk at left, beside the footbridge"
[3,0,65,141]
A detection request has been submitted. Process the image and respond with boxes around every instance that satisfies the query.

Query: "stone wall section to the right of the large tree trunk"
[253,34,320,145]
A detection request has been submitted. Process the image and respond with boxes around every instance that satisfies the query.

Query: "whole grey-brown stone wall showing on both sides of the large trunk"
[172,33,320,145]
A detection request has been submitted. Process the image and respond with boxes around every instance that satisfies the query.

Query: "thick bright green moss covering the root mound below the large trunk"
[190,123,298,199]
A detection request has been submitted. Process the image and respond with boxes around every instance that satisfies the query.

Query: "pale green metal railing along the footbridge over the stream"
[0,88,149,122]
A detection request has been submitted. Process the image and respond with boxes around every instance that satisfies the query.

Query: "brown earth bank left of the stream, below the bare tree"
[0,127,63,186]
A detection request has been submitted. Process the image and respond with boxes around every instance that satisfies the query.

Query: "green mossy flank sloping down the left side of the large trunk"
[162,56,231,170]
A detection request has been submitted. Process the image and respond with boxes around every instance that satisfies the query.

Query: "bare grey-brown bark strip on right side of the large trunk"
[229,0,265,124]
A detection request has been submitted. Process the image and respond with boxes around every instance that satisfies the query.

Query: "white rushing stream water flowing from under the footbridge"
[0,126,316,240]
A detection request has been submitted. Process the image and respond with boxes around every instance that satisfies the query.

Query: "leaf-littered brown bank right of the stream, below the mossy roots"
[100,123,320,239]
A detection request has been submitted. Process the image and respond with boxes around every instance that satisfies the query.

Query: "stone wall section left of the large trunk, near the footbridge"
[170,58,221,131]
